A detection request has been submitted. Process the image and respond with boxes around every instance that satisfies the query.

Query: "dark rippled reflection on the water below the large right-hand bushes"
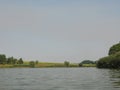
[109,70,120,88]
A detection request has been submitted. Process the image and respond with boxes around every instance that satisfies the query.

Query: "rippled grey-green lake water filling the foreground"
[0,68,120,90]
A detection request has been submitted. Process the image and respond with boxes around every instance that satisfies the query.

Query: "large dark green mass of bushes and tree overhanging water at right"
[97,43,120,69]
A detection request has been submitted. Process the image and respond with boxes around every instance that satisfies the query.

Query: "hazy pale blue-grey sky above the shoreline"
[0,0,120,62]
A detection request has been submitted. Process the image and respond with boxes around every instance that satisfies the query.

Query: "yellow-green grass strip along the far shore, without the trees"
[0,62,96,68]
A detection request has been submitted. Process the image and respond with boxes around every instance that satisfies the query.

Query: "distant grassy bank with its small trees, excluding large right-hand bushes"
[0,54,96,68]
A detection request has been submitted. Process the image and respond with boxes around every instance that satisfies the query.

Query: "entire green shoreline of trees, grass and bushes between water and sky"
[0,43,120,69]
